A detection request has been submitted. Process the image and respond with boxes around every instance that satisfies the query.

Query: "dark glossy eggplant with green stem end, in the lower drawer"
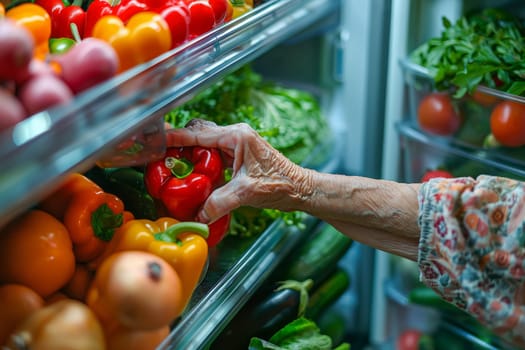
[210,280,312,350]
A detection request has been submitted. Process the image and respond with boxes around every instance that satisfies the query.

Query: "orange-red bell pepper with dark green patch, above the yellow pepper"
[39,173,133,262]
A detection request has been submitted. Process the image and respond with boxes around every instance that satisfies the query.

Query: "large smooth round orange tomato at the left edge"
[0,209,75,298]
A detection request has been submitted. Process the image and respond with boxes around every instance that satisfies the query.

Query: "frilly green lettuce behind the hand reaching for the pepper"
[165,66,330,236]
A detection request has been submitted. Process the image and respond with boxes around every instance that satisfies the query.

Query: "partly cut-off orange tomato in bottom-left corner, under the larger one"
[0,284,44,345]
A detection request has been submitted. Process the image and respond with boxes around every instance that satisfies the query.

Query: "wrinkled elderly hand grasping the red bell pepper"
[167,119,311,222]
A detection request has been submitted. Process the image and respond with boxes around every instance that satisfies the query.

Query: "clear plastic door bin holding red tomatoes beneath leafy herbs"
[400,59,525,166]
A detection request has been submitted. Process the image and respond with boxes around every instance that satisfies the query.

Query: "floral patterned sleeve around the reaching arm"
[418,175,525,347]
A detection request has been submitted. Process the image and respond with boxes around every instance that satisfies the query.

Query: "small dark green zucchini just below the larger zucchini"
[305,268,350,322]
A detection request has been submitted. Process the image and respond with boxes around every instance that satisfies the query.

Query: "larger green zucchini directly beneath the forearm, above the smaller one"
[277,223,353,285]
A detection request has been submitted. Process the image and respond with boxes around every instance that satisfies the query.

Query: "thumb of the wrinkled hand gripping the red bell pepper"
[197,180,241,223]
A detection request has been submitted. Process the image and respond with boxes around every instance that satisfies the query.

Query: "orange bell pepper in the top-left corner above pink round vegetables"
[5,2,51,60]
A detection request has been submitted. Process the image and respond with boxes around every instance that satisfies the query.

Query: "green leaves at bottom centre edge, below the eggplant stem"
[249,317,350,350]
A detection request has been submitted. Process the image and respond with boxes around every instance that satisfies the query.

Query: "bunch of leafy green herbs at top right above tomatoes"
[410,9,525,97]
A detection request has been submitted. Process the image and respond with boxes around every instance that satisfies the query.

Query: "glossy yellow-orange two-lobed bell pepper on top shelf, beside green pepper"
[92,11,171,72]
